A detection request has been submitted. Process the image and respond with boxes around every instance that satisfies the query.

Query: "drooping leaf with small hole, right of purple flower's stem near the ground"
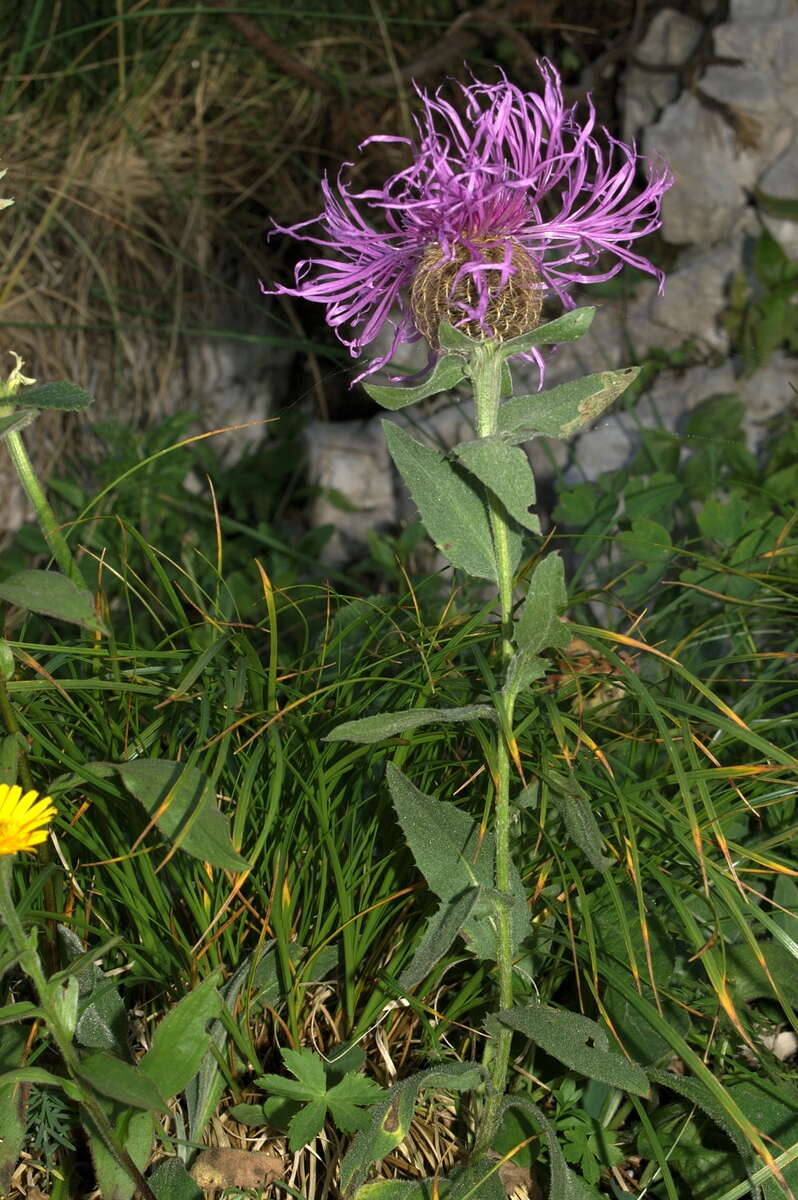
[498,1003,650,1096]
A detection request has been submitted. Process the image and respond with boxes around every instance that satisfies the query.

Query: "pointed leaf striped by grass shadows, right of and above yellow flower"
[113,758,250,871]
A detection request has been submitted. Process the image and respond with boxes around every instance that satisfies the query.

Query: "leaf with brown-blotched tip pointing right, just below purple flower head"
[498,367,640,442]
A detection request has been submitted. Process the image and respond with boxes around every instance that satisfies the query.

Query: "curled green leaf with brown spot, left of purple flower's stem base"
[341,1062,485,1196]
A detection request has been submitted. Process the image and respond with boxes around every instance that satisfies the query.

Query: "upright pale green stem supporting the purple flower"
[470,342,515,1158]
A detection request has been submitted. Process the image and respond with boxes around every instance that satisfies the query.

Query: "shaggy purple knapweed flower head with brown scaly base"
[267,59,672,379]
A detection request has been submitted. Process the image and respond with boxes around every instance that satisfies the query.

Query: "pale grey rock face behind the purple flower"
[300,0,798,565]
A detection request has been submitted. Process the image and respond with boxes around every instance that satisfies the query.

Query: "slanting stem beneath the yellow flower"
[0,854,157,1200]
